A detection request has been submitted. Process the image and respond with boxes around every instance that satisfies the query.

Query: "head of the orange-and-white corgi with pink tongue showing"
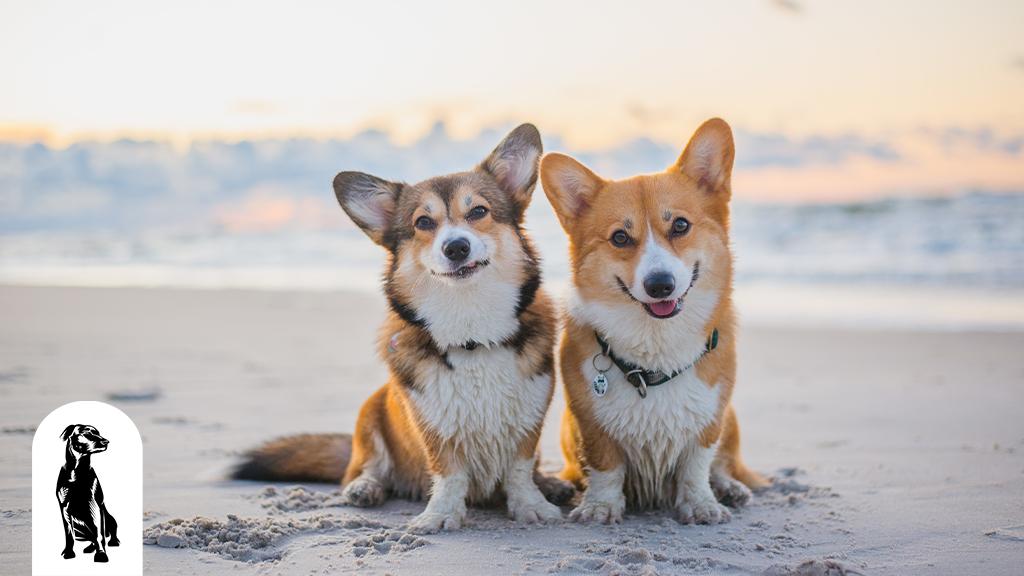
[541,118,734,324]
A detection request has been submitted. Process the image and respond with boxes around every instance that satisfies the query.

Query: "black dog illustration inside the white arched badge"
[57,424,121,562]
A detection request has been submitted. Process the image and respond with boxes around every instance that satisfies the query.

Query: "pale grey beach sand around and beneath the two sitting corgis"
[0,286,1024,576]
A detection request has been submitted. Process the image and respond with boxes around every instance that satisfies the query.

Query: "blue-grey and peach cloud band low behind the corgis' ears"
[0,123,1024,234]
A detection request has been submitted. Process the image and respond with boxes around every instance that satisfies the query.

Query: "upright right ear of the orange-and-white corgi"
[675,118,736,202]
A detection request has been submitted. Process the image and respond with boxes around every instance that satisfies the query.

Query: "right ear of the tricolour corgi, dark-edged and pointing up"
[480,124,544,221]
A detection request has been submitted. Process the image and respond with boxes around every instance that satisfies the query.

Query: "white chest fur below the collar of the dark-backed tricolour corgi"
[410,346,553,498]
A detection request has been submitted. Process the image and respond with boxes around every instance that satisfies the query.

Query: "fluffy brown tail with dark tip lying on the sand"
[231,434,352,484]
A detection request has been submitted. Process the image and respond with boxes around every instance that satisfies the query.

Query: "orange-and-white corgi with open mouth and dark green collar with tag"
[541,119,765,524]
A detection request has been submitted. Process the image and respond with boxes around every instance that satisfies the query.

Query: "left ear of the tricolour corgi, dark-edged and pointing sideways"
[334,168,404,244]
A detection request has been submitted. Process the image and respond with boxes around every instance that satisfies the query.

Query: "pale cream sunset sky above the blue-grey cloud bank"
[0,0,1024,199]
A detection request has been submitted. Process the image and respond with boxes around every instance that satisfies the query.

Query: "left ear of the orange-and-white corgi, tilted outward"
[541,153,604,236]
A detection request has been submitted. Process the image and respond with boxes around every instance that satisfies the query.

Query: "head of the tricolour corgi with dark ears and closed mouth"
[334,124,543,342]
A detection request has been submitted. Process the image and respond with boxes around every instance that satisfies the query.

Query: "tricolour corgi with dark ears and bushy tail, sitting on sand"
[233,124,574,533]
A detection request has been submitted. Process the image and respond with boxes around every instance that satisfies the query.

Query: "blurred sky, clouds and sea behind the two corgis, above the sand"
[0,0,1024,330]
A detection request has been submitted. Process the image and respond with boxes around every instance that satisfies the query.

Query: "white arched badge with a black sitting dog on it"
[32,402,142,576]
